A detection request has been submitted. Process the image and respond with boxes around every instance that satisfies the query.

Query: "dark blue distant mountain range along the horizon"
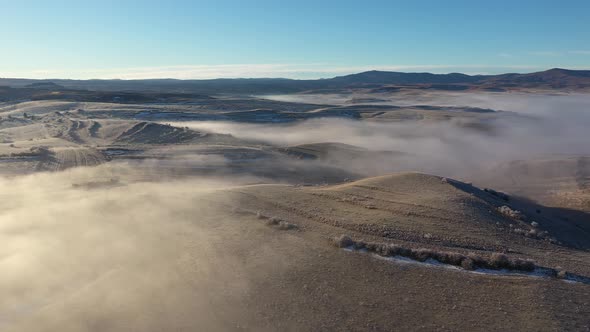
[0,68,590,94]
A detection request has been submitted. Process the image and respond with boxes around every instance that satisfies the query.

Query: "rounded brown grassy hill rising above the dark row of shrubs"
[229,173,590,260]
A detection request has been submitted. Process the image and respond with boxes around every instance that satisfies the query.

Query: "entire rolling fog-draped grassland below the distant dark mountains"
[0,87,590,331]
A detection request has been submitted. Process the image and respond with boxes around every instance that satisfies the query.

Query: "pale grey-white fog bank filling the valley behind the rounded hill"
[172,94,590,178]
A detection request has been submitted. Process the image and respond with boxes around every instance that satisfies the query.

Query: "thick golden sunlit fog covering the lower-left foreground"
[0,164,270,331]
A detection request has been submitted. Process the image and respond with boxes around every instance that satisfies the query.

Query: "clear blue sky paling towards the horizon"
[0,0,590,79]
